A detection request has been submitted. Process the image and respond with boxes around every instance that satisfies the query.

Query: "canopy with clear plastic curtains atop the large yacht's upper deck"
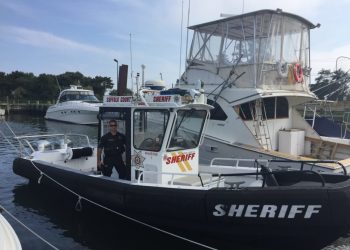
[187,9,318,91]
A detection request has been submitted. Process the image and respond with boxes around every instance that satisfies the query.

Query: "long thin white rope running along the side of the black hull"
[30,160,217,250]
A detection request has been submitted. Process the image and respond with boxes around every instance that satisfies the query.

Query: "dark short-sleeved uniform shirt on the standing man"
[98,132,125,158]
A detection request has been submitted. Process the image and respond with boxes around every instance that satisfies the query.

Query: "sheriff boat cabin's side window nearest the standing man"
[133,110,169,151]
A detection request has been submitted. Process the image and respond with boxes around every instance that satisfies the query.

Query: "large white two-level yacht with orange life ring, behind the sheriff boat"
[178,9,350,171]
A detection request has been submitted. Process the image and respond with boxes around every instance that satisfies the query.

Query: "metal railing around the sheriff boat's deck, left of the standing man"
[14,134,91,156]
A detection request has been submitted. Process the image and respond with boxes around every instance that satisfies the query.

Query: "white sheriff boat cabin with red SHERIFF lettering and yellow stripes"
[99,91,211,185]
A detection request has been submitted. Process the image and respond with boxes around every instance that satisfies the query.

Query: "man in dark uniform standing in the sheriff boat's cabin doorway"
[97,120,129,179]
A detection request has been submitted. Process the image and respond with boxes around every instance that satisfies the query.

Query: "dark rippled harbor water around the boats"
[0,115,350,250]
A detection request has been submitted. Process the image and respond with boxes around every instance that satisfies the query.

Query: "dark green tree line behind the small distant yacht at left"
[0,71,113,102]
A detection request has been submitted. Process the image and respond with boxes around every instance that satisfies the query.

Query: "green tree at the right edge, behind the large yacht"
[310,69,350,101]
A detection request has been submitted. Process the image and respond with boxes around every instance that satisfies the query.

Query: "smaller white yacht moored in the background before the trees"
[45,85,101,125]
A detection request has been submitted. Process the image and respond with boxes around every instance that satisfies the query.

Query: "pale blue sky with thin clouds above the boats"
[0,0,350,90]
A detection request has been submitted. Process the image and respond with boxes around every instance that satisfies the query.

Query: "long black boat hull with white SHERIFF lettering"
[13,158,350,249]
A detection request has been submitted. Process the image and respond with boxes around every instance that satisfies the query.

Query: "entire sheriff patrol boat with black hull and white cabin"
[13,87,350,249]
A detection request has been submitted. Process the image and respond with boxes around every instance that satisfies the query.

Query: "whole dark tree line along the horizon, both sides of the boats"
[0,69,350,102]
